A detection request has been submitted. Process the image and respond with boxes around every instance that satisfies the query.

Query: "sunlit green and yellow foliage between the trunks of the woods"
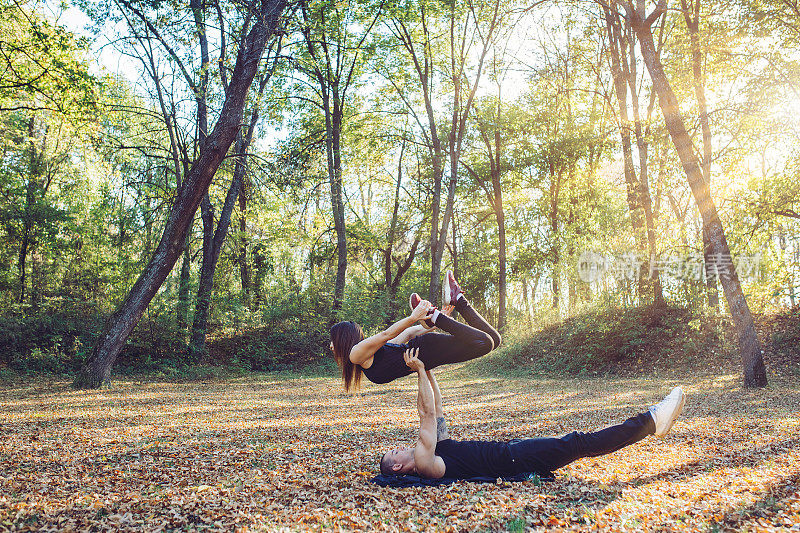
[0,0,800,386]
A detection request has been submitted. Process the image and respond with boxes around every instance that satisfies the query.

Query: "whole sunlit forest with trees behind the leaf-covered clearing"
[0,0,800,386]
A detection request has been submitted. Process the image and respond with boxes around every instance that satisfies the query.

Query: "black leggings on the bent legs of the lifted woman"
[408,297,500,370]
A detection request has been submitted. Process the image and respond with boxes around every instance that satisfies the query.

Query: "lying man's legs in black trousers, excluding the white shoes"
[510,411,656,475]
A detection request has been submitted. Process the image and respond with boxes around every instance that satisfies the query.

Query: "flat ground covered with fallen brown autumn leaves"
[0,368,800,531]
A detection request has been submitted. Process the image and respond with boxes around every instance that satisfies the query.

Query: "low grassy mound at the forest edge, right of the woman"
[474,308,800,376]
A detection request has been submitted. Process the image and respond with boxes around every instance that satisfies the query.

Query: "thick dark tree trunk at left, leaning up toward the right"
[75,0,286,388]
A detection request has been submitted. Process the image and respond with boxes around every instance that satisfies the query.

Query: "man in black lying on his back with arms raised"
[381,350,686,479]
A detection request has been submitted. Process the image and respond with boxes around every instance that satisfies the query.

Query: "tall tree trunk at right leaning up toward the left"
[627,1,767,387]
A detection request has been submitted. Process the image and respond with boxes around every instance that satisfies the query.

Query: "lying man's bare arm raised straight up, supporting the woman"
[403,350,445,478]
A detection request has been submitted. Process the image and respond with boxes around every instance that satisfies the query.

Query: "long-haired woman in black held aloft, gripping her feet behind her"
[331,271,500,391]
